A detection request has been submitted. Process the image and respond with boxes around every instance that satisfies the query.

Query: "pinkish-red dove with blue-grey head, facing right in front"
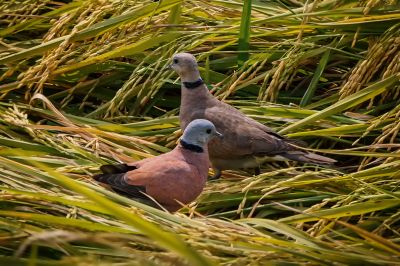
[94,119,222,212]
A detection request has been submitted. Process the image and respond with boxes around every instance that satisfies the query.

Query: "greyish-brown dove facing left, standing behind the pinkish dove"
[170,53,336,178]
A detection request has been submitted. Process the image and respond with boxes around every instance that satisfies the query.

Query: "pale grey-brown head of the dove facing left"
[170,53,200,80]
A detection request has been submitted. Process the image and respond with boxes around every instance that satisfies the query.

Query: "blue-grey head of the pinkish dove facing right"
[182,119,222,147]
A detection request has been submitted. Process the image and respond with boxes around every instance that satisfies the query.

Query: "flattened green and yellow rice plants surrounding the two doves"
[0,0,400,266]
